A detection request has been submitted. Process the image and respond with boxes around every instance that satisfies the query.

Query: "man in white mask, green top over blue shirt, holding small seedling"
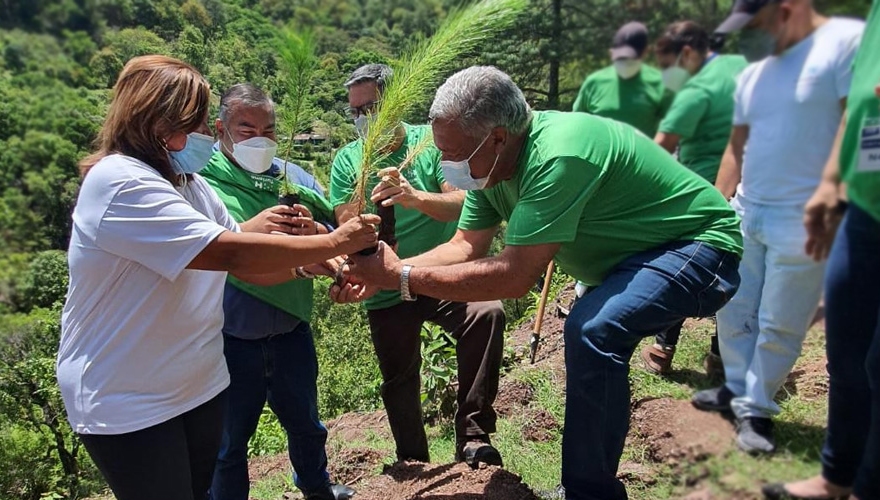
[201,84,353,500]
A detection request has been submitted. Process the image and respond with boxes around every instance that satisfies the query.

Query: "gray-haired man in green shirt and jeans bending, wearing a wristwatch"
[331,67,742,500]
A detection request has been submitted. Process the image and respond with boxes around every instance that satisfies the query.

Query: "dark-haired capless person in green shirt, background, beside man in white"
[641,21,748,377]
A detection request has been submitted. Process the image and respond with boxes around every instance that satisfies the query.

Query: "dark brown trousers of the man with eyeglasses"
[368,297,504,462]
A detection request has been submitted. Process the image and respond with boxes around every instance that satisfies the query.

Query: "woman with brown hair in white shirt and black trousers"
[57,56,378,500]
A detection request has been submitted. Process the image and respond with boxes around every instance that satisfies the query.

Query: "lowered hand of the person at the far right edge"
[804,180,843,262]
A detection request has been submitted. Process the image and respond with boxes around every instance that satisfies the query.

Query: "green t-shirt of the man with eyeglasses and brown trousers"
[330,123,456,309]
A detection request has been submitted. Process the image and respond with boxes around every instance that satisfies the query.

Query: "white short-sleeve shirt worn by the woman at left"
[57,155,238,434]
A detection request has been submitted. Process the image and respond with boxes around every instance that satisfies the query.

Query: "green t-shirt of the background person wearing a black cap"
[572,64,675,139]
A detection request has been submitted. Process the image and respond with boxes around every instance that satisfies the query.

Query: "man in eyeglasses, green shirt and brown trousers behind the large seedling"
[330,64,505,467]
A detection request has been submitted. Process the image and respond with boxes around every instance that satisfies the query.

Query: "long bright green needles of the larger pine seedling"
[352,0,528,212]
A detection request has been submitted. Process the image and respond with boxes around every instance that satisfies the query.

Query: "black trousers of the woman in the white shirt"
[79,391,226,500]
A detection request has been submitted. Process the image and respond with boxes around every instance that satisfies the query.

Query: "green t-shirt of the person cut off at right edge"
[840,0,880,221]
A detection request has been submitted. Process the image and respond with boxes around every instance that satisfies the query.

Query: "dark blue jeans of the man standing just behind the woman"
[211,323,330,500]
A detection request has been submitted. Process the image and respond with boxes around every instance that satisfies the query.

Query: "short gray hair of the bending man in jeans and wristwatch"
[428,66,532,137]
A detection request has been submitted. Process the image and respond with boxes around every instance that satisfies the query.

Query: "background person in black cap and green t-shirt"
[572,22,674,137]
